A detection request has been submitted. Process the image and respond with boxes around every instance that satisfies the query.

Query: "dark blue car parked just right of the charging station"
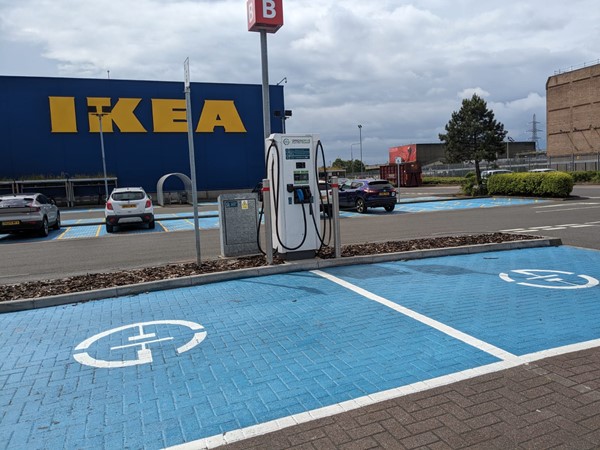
[339,179,396,214]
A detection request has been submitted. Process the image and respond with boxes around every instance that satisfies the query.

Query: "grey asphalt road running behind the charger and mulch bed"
[0,185,600,284]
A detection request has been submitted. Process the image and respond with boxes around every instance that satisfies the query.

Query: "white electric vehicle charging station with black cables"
[265,134,321,259]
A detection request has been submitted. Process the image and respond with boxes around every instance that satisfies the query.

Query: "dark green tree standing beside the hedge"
[439,94,506,185]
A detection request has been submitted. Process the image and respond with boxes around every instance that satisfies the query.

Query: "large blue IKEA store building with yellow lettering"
[0,76,284,197]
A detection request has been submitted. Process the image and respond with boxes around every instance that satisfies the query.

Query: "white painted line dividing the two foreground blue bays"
[311,270,518,362]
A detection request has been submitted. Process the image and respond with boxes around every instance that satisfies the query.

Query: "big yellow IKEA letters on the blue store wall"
[48,97,246,133]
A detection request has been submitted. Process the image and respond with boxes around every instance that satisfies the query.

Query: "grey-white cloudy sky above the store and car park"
[0,0,600,163]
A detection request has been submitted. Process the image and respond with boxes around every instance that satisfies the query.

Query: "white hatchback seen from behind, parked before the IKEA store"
[104,187,154,233]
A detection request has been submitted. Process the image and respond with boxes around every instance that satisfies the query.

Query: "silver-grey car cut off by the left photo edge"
[0,192,60,236]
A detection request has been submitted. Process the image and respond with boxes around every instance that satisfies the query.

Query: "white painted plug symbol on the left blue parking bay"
[73,320,206,369]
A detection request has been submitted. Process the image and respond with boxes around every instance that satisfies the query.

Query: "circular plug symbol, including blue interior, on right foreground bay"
[499,269,600,289]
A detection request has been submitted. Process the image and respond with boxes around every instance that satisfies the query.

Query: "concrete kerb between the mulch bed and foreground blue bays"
[0,237,562,314]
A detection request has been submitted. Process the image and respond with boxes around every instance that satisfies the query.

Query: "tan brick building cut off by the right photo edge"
[546,64,600,158]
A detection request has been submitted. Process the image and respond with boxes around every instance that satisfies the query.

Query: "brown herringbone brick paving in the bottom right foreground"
[221,348,600,450]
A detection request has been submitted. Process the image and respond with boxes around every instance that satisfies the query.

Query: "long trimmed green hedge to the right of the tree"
[487,172,574,198]
